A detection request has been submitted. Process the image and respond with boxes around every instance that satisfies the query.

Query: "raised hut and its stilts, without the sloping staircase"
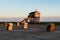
[28,11,40,23]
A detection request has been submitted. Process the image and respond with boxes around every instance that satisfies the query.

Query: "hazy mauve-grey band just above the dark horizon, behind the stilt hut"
[0,17,60,22]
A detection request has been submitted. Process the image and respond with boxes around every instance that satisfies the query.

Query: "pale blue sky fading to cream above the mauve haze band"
[0,0,60,18]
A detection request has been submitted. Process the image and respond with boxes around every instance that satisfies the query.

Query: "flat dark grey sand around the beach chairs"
[0,24,60,40]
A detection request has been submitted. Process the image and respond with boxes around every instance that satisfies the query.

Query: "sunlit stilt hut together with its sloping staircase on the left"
[21,11,40,23]
